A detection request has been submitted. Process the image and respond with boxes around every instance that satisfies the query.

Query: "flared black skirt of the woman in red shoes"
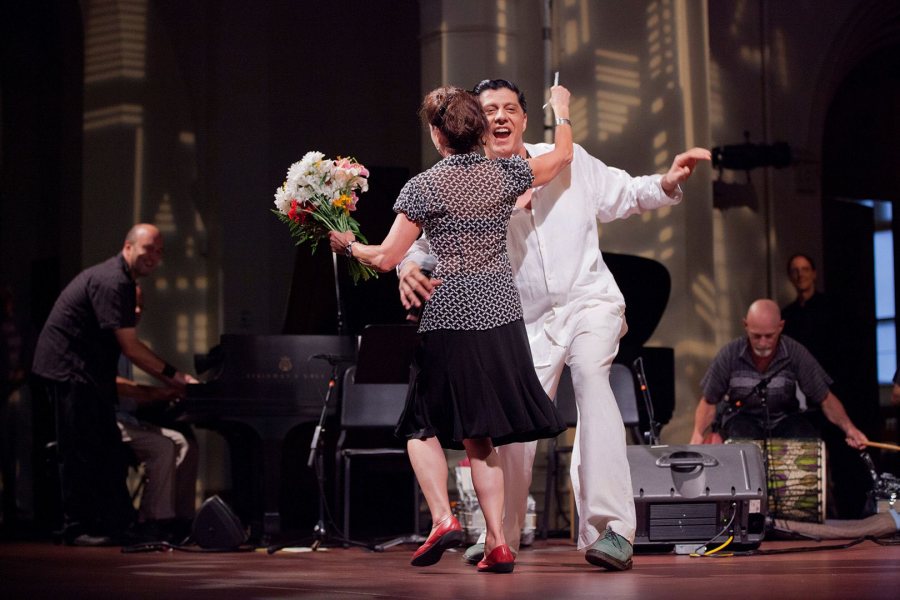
[397,319,566,450]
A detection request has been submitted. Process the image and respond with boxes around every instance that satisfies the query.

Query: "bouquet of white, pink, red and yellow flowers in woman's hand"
[272,152,377,283]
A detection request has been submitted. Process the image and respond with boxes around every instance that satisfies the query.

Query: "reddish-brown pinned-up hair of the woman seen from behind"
[419,87,488,154]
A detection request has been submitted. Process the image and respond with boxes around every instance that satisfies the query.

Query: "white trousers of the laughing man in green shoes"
[488,305,635,552]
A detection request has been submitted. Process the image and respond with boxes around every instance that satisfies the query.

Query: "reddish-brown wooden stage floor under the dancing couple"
[0,540,900,600]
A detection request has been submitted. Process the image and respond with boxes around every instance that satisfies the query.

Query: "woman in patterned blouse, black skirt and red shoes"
[330,86,573,573]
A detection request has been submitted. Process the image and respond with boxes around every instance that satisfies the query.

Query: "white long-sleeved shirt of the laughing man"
[405,144,682,366]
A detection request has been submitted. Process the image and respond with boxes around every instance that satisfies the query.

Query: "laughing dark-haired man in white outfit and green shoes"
[399,79,710,570]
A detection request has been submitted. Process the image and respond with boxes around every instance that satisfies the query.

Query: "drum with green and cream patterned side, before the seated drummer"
[729,438,827,523]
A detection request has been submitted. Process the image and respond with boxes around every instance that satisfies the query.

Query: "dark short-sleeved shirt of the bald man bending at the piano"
[32,254,136,386]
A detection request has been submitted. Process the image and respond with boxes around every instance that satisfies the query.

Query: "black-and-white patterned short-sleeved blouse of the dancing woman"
[394,153,534,332]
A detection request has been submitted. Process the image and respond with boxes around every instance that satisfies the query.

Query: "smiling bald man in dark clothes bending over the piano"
[32,224,196,546]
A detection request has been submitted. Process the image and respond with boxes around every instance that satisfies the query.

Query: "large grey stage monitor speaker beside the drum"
[628,444,767,547]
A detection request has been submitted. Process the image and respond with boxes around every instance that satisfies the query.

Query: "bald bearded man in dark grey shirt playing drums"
[691,299,869,450]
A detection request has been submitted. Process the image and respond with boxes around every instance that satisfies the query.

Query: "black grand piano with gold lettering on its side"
[180,334,355,542]
